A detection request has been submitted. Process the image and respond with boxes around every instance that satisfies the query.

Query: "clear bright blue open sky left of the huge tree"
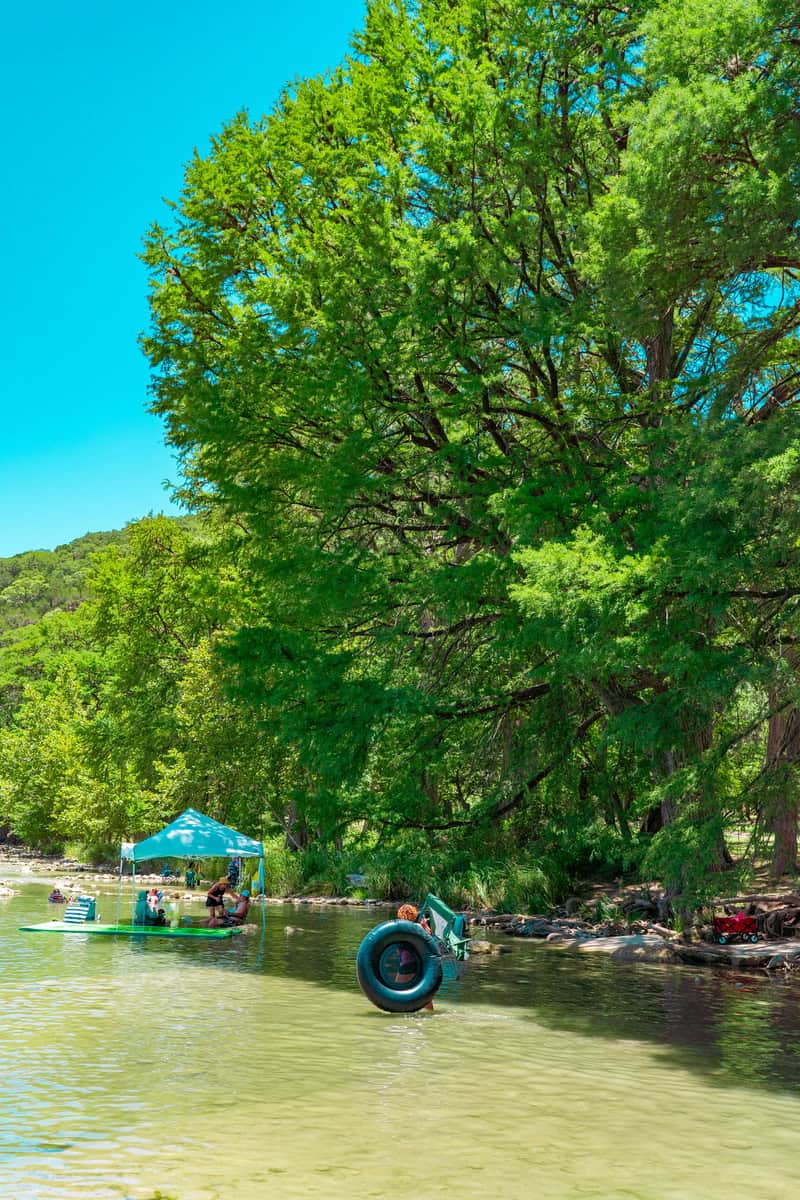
[0,0,365,556]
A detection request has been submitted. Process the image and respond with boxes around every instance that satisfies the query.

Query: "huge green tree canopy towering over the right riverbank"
[134,0,800,902]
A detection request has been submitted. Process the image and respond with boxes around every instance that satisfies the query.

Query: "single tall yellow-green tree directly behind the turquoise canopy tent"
[73,517,292,834]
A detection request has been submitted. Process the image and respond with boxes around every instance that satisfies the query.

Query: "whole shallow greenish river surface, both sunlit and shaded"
[0,882,800,1200]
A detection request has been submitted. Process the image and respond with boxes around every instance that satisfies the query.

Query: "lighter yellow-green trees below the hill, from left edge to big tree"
[0,517,296,853]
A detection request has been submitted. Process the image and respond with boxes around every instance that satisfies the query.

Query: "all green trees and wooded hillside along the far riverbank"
[0,0,800,912]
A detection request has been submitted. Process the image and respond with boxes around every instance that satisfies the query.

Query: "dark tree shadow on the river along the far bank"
[14,889,800,1091]
